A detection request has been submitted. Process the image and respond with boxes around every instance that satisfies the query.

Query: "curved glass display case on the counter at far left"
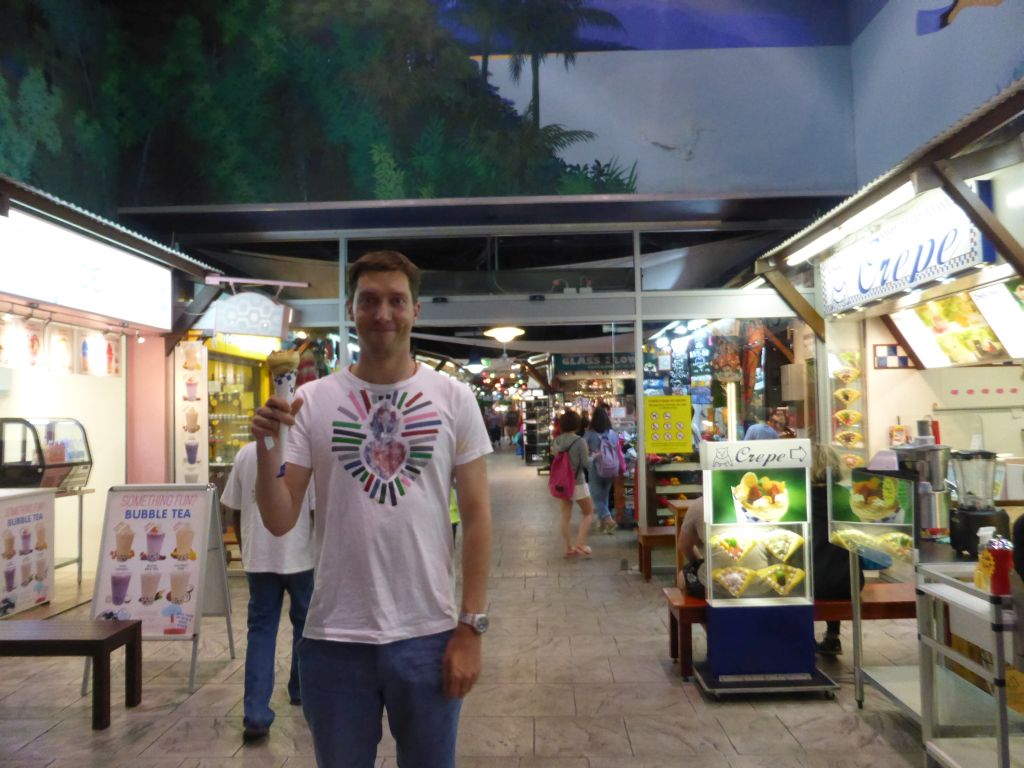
[0,418,92,492]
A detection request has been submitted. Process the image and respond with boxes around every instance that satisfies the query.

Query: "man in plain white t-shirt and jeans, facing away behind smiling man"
[220,442,313,741]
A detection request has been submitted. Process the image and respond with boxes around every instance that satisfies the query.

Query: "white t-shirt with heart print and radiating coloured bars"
[286,366,493,644]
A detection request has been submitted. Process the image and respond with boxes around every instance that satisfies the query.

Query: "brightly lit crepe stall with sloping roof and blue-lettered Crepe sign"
[759,87,1024,768]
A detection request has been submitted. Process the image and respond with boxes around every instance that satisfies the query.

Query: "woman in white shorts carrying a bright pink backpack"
[549,411,594,558]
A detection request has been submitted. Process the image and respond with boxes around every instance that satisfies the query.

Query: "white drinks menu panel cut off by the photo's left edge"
[0,488,53,616]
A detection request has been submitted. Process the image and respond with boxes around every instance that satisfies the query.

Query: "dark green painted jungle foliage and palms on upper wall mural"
[0,0,636,211]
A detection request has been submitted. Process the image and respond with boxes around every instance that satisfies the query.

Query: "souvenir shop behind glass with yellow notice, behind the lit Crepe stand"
[642,317,814,526]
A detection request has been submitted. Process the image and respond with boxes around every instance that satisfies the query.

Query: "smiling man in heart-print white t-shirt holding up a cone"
[253,251,493,768]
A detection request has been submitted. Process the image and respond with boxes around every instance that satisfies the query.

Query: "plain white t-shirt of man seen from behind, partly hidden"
[220,442,314,573]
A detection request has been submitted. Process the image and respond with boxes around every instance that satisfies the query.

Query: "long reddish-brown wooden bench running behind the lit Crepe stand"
[662,582,918,678]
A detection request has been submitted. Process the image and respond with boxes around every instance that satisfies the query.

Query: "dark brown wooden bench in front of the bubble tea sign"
[0,620,142,730]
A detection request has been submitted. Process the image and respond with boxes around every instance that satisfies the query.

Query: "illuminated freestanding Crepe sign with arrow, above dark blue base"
[700,439,811,606]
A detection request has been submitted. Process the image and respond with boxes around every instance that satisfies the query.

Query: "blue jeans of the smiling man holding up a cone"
[299,630,462,768]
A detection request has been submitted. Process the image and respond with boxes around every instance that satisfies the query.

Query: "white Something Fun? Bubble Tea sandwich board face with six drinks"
[92,485,214,640]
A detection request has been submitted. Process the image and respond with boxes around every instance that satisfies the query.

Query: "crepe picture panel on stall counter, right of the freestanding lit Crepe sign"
[829,469,914,567]
